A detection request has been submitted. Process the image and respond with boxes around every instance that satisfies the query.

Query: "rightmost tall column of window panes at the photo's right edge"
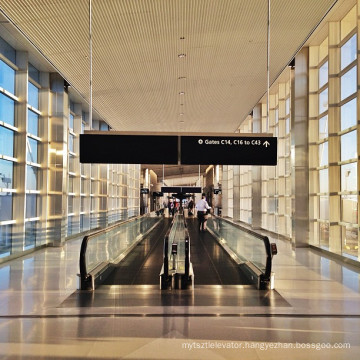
[337,7,359,257]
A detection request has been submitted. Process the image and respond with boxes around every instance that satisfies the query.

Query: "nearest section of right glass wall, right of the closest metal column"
[309,6,359,259]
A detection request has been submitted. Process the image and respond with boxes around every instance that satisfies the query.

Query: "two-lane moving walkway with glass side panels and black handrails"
[80,213,275,290]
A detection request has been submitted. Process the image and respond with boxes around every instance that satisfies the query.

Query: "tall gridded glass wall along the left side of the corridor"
[0,38,140,261]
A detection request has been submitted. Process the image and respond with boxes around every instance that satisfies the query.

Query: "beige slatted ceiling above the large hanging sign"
[0,0,334,132]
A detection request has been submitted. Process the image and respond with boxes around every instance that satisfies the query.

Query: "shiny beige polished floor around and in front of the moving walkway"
[0,218,360,360]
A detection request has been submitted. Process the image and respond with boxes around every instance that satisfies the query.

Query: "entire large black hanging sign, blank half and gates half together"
[80,132,277,165]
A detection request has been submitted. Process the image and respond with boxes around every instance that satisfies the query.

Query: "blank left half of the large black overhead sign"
[80,132,178,165]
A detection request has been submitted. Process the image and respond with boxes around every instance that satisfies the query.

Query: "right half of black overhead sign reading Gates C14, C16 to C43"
[181,136,277,165]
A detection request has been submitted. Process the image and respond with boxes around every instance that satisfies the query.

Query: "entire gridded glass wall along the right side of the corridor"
[231,1,360,260]
